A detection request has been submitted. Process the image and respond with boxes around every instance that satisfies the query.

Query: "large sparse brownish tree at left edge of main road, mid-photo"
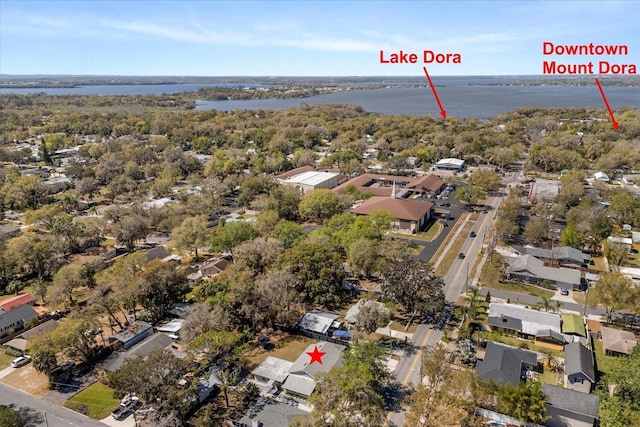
[382,260,444,314]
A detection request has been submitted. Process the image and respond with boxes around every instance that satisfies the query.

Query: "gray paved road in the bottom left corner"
[0,384,105,427]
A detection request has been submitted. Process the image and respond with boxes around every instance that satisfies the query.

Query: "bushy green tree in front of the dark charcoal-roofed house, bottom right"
[497,381,548,424]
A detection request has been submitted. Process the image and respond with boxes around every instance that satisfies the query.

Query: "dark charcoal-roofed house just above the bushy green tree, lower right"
[476,342,538,385]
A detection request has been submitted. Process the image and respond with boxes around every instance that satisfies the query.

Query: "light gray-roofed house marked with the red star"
[282,341,345,399]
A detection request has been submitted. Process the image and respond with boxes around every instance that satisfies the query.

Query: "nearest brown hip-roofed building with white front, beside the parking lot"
[351,197,433,233]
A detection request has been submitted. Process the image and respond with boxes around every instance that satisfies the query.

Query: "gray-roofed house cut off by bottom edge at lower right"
[542,383,600,427]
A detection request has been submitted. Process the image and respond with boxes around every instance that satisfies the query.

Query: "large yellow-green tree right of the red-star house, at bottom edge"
[311,341,390,427]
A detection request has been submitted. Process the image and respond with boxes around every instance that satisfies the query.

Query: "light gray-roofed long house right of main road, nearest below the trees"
[505,255,580,289]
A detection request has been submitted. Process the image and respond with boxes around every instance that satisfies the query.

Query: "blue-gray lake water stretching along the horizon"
[0,76,640,118]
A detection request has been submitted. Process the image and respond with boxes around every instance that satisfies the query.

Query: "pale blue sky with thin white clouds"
[0,0,640,76]
